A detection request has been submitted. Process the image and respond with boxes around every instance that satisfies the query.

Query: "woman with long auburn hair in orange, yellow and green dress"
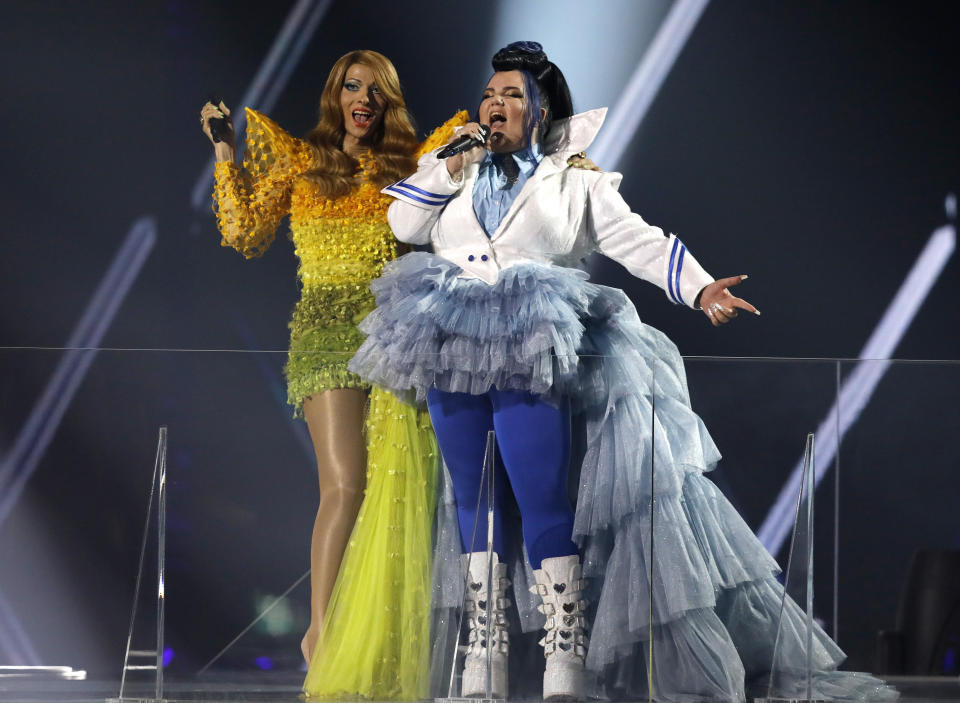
[201,51,466,699]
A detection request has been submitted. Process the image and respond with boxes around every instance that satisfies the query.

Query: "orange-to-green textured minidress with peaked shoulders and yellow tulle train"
[214,109,467,700]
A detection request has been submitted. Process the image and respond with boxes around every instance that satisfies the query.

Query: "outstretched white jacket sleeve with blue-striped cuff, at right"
[588,173,713,307]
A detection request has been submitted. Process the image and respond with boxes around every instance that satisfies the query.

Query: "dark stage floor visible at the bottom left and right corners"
[0,674,960,703]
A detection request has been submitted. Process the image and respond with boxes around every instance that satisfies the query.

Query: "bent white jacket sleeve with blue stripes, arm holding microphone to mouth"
[380,152,461,244]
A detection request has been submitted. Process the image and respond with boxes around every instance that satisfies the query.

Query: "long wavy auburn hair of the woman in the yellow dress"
[305,49,418,197]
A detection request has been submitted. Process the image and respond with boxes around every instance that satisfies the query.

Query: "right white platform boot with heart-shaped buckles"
[530,555,587,699]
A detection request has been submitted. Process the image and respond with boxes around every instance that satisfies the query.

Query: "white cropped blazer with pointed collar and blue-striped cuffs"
[382,108,713,307]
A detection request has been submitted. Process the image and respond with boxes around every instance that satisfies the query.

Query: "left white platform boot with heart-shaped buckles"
[460,552,510,698]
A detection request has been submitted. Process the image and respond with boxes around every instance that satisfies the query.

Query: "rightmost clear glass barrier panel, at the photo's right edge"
[838,360,960,677]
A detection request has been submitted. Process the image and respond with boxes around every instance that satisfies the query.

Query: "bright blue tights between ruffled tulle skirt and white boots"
[427,388,579,569]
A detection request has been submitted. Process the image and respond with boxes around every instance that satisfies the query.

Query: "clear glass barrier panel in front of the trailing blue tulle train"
[653,357,836,699]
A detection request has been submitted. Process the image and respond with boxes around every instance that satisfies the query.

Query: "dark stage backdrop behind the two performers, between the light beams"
[0,0,960,675]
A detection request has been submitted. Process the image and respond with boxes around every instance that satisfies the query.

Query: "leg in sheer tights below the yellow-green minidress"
[300,388,367,665]
